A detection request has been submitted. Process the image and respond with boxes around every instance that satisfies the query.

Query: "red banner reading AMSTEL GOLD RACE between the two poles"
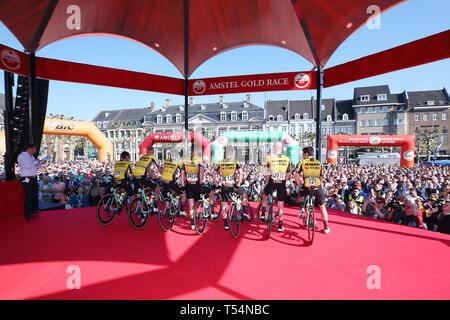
[189,71,317,96]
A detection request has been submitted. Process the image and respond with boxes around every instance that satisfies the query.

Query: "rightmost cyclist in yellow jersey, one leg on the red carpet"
[294,147,330,233]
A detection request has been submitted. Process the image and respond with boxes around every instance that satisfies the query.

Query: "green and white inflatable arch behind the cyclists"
[212,131,299,164]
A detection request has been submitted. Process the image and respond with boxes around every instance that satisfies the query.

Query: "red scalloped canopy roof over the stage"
[0,0,404,76]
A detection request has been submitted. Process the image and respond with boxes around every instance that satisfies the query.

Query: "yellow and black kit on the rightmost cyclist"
[295,158,325,205]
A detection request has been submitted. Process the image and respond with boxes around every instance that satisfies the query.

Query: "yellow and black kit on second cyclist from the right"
[263,155,291,201]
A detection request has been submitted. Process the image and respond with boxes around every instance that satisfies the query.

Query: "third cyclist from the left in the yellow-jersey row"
[155,149,186,216]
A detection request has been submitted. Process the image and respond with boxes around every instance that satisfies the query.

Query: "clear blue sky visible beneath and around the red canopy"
[0,0,450,120]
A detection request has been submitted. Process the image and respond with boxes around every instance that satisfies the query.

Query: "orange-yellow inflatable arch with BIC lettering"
[44,118,113,162]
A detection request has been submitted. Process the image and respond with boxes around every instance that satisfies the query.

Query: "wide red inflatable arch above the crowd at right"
[327,135,416,167]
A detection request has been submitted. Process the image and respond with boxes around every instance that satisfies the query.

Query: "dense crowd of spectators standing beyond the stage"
[0,161,450,234]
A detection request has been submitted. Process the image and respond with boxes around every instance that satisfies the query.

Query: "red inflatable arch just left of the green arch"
[139,132,211,162]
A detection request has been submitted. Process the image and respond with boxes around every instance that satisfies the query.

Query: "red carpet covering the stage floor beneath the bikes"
[0,208,450,299]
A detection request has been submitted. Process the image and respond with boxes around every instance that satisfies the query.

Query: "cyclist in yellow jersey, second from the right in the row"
[261,141,291,232]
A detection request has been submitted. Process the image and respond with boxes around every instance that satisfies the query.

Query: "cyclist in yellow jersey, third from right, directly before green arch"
[213,146,248,230]
